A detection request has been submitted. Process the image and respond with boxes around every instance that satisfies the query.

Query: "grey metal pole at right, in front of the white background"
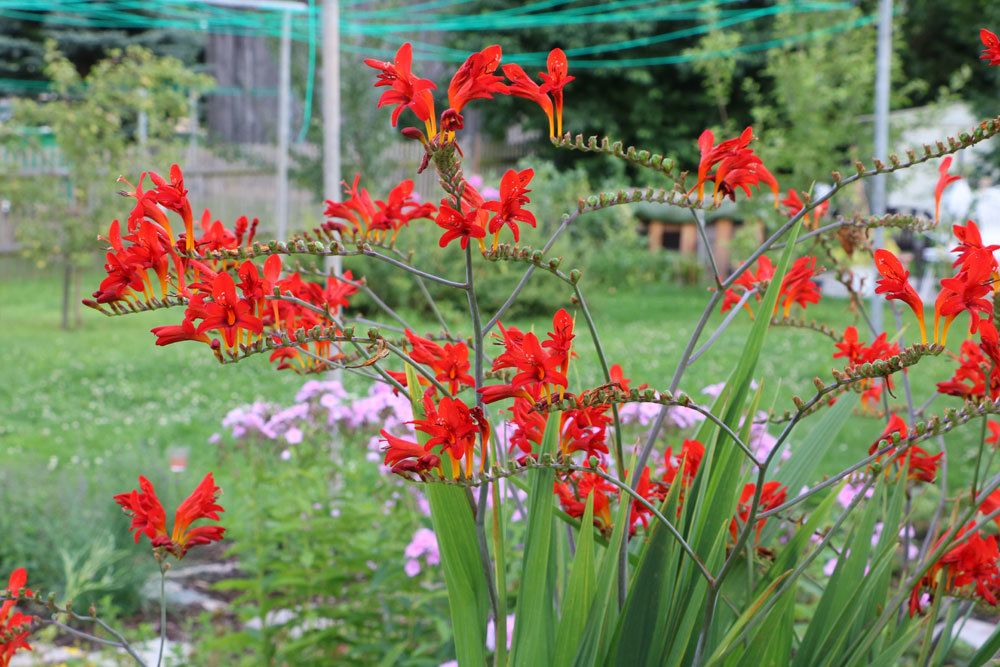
[871,0,892,332]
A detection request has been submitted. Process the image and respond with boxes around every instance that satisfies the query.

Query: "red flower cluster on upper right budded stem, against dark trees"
[688,127,780,206]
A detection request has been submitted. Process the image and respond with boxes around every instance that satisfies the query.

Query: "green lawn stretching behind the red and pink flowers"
[0,262,979,496]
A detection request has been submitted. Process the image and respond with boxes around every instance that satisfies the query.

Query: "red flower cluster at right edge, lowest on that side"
[910,522,1000,616]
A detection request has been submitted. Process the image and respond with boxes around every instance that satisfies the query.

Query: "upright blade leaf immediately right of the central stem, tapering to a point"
[510,412,560,666]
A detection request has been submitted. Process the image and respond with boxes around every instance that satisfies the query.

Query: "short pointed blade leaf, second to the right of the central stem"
[553,493,597,667]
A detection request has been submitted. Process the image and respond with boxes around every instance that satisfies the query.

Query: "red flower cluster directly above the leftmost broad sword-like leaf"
[381,387,490,478]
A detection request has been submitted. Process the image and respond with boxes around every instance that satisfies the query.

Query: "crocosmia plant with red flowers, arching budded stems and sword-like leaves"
[0,30,1000,666]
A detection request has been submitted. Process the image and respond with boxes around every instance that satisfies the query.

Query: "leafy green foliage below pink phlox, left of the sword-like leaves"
[199,396,454,666]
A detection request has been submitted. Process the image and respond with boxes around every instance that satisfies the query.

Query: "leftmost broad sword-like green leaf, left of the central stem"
[406,364,488,667]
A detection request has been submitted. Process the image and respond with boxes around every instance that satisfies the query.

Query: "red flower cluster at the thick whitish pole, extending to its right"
[323,174,436,243]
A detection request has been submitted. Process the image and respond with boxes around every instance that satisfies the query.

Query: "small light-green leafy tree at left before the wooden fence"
[4,42,212,328]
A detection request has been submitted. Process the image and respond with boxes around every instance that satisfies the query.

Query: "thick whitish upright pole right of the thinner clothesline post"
[323,0,342,276]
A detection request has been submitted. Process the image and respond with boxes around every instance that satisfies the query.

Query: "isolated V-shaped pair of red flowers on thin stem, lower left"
[115,473,226,560]
